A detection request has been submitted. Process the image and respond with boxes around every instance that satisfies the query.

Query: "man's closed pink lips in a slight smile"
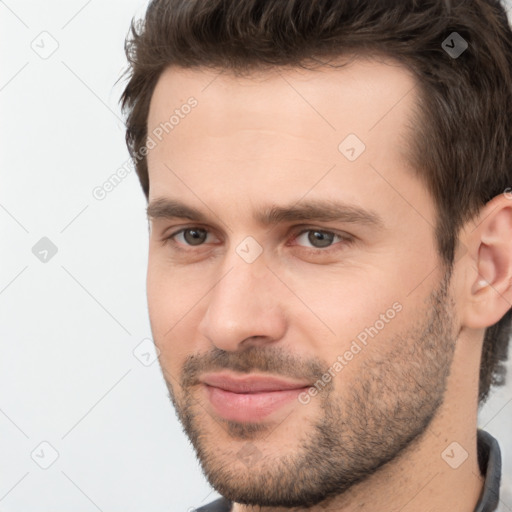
[201,373,311,422]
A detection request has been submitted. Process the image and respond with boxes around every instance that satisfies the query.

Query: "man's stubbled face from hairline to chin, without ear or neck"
[147,60,456,506]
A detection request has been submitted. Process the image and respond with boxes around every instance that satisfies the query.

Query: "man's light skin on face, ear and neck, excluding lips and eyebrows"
[143,58,512,512]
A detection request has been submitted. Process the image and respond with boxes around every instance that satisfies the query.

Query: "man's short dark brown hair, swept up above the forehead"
[121,0,512,403]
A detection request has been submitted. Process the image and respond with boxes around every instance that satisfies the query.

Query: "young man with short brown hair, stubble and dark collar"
[122,0,512,512]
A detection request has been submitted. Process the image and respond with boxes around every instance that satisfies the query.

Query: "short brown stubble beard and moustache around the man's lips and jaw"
[164,273,456,508]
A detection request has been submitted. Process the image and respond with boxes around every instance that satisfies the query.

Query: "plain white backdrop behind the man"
[0,0,512,512]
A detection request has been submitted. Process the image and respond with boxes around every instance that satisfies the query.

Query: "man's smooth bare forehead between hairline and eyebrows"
[147,58,430,230]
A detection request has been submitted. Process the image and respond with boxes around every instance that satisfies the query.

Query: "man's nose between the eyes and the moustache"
[199,254,286,351]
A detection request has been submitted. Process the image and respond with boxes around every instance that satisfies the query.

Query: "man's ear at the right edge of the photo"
[461,189,512,329]
